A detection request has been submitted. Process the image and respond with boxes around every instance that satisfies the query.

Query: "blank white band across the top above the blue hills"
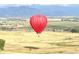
[0,0,79,4]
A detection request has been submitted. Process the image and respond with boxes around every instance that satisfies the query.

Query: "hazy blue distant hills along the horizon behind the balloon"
[0,4,79,17]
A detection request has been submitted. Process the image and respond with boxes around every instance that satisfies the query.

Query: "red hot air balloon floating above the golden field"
[30,15,47,34]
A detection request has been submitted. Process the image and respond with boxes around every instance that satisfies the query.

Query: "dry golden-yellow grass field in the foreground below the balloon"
[0,31,79,54]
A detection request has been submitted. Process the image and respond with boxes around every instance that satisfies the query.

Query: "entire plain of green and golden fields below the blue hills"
[0,20,79,54]
